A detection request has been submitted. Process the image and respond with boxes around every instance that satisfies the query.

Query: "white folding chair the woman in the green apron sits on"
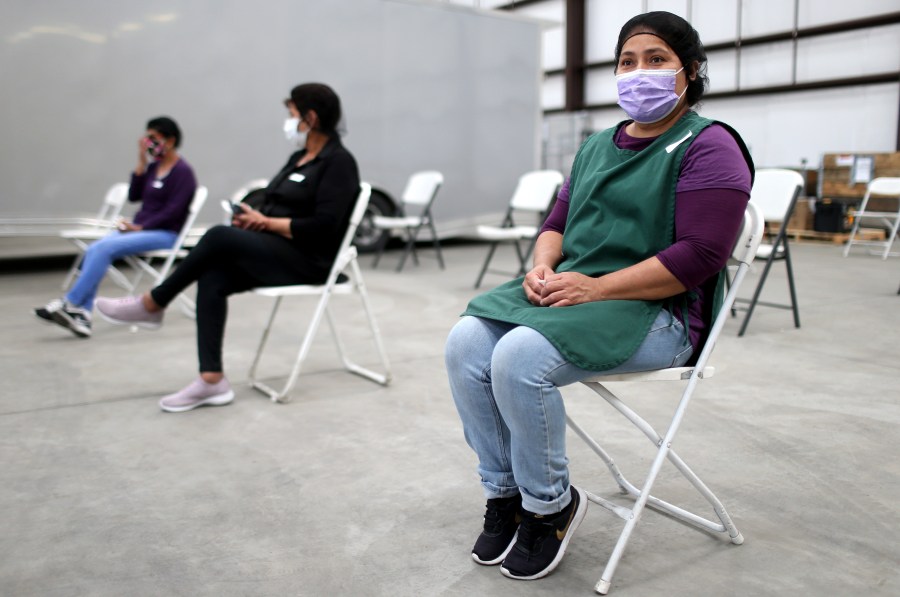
[566,203,763,595]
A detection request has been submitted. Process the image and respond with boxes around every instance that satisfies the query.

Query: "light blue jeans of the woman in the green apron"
[445,307,693,515]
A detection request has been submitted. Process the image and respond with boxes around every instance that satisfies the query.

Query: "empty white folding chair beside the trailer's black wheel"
[372,170,444,272]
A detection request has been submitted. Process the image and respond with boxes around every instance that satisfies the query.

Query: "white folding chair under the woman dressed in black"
[248,182,391,402]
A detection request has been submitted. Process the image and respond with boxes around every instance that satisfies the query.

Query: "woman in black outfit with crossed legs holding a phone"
[97,83,359,412]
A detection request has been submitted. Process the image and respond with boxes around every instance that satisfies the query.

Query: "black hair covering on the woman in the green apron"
[616,10,709,106]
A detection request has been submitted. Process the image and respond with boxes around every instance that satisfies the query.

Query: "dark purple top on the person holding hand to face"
[128,158,197,232]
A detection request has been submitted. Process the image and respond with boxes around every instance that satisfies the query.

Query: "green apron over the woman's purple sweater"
[464,111,721,371]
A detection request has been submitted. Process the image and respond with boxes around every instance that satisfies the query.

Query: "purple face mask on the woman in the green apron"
[616,67,687,124]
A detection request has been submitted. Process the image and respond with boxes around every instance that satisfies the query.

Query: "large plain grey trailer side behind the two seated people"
[0,0,541,241]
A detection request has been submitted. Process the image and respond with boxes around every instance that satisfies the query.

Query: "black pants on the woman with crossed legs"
[150,226,331,372]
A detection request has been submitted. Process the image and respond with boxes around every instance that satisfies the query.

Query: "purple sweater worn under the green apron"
[541,124,751,349]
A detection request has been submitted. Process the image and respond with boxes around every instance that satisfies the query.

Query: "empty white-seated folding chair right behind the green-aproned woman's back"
[732,168,804,336]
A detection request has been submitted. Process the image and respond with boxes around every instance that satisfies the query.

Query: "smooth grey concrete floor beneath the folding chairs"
[0,244,900,597]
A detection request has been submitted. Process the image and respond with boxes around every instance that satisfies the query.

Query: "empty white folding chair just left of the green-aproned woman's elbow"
[475,170,564,288]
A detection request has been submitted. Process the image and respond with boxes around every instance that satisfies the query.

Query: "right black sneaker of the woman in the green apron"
[500,485,587,580]
